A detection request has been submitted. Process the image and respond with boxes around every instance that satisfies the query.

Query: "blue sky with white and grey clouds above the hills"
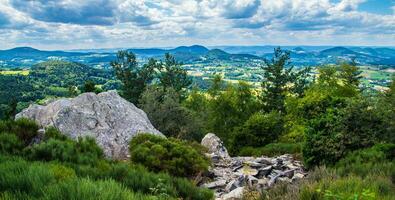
[0,0,395,50]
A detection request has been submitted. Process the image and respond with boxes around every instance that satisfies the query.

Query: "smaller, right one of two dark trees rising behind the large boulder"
[159,53,192,92]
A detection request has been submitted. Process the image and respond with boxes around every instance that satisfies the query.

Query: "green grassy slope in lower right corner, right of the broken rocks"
[261,145,395,200]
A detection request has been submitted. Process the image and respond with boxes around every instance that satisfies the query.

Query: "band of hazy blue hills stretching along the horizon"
[0,45,395,68]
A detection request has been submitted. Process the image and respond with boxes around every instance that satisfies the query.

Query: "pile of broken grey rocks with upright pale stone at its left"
[201,133,306,200]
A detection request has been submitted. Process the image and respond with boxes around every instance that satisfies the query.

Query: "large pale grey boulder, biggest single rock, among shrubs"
[16,91,163,159]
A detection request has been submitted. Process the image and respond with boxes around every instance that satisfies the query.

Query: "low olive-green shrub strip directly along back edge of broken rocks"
[239,143,302,156]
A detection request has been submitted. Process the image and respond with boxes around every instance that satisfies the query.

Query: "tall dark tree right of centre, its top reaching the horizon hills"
[260,47,309,113]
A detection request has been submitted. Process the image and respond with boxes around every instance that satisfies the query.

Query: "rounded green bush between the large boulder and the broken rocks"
[129,134,209,177]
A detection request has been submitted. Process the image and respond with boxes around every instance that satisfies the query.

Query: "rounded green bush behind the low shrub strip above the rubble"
[231,112,283,154]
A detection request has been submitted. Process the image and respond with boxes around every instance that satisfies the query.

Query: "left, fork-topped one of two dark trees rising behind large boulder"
[110,51,158,104]
